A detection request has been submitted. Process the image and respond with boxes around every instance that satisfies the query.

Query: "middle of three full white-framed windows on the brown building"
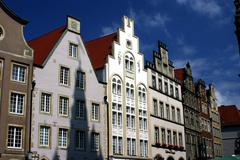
[10,92,25,115]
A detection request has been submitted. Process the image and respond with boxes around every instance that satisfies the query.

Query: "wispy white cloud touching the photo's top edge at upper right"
[176,0,222,18]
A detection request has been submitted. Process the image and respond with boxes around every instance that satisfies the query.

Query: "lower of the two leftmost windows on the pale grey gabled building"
[39,126,50,147]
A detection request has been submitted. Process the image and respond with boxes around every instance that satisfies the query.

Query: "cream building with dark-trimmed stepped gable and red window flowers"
[146,42,186,160]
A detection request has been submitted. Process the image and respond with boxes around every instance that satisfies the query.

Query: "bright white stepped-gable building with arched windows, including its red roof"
[86,16,150,160]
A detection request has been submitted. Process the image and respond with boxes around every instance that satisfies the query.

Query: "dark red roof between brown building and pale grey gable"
[28,26,66,66]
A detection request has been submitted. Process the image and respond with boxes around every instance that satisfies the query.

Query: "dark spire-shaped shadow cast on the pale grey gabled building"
[64,36,104,160]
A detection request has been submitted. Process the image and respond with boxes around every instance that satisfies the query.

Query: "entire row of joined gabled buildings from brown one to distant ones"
[0,1,222,160]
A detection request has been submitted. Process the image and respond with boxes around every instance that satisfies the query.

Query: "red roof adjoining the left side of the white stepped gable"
[85,32,117,69]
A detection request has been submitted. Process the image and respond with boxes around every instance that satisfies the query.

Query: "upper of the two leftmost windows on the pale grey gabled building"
[41,93,52,113]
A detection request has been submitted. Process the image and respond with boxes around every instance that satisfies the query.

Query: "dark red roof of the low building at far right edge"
[218,105,240,127]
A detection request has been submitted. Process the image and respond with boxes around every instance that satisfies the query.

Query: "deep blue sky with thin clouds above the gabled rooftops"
[5,0,240,107]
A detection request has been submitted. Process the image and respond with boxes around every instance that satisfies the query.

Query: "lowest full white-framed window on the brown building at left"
[7,126,23,149]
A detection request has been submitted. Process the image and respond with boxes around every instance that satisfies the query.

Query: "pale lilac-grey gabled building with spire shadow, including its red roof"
[29,17,106,160]
